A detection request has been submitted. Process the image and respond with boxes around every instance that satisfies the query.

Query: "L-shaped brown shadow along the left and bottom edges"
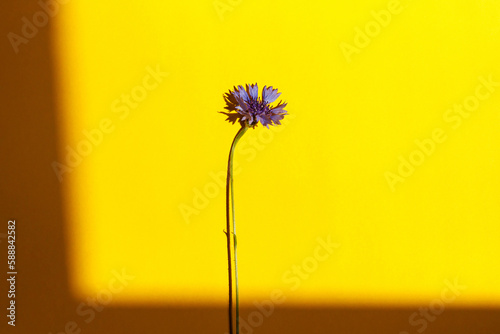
[0,0,500,334]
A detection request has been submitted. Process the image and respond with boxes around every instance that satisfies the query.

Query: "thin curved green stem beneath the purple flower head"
[226,126,248,334]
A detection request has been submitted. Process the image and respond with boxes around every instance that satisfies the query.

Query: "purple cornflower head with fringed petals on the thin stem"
[221,84,287,128]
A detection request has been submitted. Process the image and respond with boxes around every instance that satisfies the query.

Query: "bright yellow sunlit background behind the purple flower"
[54,0,500,306]
